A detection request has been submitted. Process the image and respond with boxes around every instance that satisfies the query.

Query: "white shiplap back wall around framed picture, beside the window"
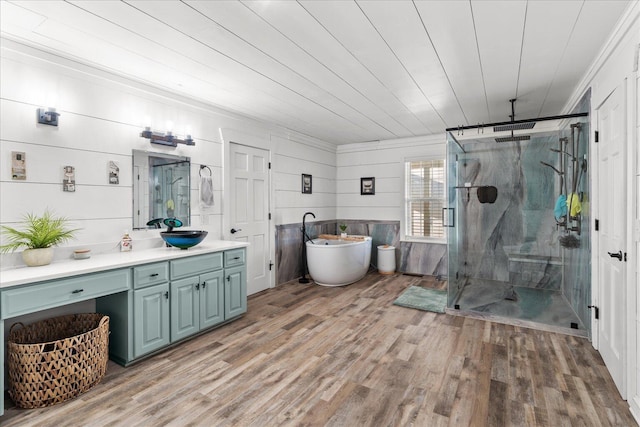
[336,135,446,234]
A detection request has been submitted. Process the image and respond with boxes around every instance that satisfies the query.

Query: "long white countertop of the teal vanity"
[0,240,249,289]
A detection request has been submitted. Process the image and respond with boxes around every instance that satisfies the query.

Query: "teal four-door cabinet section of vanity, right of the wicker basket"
[129,248,247,364]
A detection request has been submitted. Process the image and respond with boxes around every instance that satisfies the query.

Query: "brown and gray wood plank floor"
[0,273,636,427]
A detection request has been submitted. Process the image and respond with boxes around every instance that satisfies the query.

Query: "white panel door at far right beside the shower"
[595,88,627,398]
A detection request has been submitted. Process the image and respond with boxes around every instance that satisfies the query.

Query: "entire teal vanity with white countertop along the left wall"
[0,241,247,416]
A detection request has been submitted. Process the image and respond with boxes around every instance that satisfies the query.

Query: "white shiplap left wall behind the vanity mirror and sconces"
[0,39,336,268]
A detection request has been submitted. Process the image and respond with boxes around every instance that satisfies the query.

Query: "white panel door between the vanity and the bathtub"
[229,143,271,295]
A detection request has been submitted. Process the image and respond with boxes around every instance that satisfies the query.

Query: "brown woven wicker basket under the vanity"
[7,313,109,408]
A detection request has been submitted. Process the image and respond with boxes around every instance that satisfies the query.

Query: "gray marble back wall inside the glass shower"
[455,133,562,290]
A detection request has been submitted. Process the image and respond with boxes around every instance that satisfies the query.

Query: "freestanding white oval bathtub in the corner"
[306,236,371,286]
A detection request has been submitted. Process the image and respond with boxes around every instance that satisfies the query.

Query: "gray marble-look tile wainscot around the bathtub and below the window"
[276,220,447,285]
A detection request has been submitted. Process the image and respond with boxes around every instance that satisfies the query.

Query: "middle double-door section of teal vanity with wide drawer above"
[170,252,225,342]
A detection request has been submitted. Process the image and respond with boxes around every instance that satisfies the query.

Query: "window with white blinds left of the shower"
[406,159,446,239]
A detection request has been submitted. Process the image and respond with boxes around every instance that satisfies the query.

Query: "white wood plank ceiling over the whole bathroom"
[0,0,631,145]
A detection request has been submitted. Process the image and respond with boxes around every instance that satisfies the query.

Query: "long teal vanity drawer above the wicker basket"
[1,268,131,319]
